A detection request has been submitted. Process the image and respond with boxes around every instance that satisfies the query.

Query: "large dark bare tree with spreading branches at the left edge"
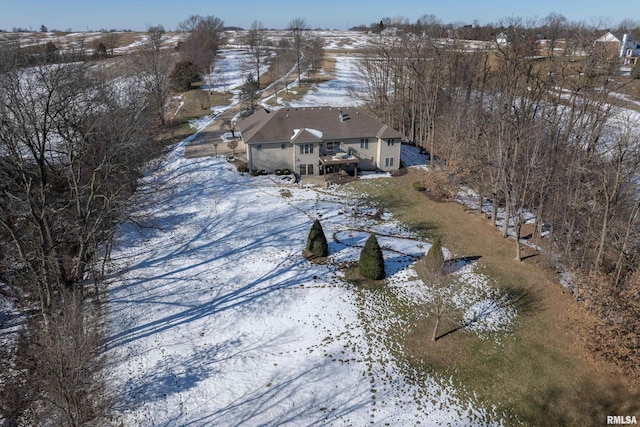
[0,49,149,318]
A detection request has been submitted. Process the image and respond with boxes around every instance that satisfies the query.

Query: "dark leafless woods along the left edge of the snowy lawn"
[0,25,172,426]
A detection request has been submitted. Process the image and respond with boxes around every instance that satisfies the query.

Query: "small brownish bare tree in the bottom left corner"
[16,294,114,427]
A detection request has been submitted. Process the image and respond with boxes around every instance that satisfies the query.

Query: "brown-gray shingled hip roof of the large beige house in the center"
[238,107,402,144]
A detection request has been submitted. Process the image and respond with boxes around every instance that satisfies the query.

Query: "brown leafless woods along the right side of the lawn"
[360,16,640,374]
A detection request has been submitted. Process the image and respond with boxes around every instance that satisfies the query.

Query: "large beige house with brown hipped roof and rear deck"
[238,107,403,175]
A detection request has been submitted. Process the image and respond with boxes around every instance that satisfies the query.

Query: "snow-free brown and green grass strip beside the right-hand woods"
[352,171,640,425]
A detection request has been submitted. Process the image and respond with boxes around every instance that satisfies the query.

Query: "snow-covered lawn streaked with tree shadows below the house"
[108,139,513,426]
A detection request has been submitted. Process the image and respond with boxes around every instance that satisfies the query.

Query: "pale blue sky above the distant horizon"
[0,0,640,31]
